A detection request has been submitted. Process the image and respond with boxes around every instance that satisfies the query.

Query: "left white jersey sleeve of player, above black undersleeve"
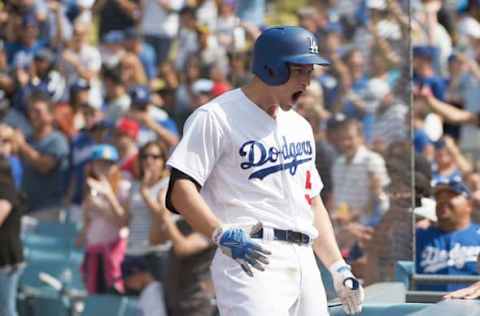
[167,109,224,186]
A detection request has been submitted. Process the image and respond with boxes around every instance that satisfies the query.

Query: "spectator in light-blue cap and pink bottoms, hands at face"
[80,144,131,294]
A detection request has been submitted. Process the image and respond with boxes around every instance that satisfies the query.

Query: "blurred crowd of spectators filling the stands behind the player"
[0,0,466,316]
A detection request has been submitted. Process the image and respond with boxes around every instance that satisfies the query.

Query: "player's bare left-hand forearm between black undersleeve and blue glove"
[171,179,221,238]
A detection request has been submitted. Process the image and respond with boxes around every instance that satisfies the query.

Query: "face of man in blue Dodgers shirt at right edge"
[435,189,471,229]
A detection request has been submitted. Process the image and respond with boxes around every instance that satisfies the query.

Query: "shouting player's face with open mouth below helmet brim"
[274,65,313,111]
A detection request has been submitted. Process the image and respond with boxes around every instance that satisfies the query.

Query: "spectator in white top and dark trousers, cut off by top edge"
[141,0,185,65]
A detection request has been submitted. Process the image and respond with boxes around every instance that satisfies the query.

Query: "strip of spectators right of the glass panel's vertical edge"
[412,1,480,297]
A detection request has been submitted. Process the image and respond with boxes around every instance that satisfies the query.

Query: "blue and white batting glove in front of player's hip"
[212,227,271,277]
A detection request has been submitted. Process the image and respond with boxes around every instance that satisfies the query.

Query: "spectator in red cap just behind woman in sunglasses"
[113,117,140,176]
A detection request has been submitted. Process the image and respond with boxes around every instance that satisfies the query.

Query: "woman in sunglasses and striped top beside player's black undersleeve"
[127,141,169,282]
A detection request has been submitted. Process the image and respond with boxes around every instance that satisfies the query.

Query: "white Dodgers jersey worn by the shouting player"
[167,89,323,238]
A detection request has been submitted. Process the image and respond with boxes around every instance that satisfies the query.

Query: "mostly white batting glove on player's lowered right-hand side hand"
[328,260,365,315]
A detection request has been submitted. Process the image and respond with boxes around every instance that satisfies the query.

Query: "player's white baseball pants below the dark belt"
[211,239,328,316]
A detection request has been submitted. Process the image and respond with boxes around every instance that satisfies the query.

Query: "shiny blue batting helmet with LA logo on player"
[252,26,329,86]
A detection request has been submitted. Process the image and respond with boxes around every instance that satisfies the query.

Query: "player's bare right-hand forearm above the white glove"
[312,196,342,267]
